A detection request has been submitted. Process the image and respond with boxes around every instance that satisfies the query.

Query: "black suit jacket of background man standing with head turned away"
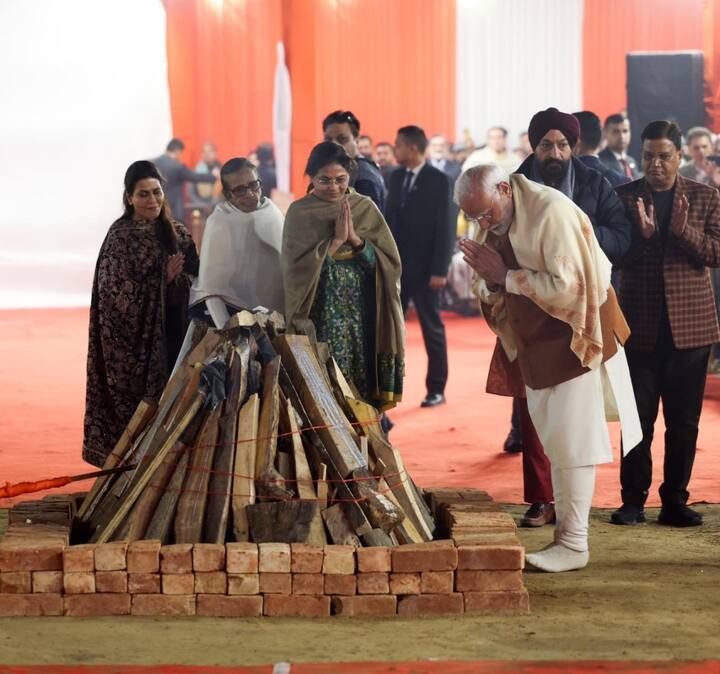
[385,164,455,289]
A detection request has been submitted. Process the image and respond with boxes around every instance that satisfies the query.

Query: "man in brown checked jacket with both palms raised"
[611,120,720,527]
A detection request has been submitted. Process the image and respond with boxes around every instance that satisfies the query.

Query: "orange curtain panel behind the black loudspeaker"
[583,0,704,119]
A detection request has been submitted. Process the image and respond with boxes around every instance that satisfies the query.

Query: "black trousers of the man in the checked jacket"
[620,336,710,507]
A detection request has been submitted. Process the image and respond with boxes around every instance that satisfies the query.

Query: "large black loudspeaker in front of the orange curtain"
[627,51,705,162]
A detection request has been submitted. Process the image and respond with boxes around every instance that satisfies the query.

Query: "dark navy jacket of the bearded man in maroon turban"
[517,155,632,264]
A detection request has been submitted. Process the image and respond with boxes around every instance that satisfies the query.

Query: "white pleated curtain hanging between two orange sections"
[456,0,584,149]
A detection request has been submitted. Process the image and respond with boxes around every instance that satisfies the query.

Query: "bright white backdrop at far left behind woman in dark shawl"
[0,0,172,308]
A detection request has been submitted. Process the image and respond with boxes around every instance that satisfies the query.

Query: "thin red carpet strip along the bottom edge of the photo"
[0,660,720,674]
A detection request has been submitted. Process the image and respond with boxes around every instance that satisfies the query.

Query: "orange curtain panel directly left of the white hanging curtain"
[285,0,455,193]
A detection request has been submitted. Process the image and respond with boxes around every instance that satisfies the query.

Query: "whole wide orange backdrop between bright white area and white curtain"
[166,0,455,192]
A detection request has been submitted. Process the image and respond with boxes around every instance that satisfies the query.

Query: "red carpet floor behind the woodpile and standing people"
[0,309,720,507]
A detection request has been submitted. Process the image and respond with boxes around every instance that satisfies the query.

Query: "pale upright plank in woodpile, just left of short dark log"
[232,393,260,541]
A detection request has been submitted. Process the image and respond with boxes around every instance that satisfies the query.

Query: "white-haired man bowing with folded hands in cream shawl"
[455,165,641,572]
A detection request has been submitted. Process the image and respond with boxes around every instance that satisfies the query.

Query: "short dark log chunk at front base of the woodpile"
[245,500,317,543]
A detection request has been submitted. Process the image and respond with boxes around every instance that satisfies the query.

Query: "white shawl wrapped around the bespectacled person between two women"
[190,198,285,327]
